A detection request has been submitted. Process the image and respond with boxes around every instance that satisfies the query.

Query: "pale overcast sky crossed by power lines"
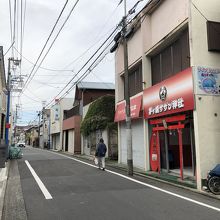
[0,0,148,125]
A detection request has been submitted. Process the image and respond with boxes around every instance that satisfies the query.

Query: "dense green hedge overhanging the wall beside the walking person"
[80,96,117,136]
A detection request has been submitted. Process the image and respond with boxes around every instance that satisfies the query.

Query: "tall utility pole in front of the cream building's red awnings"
[122,0,133,176]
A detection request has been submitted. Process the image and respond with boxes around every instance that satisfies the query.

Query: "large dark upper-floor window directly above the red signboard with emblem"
[151,30,190,85]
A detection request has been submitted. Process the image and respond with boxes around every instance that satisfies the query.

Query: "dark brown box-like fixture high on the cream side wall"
[207,21,220,52]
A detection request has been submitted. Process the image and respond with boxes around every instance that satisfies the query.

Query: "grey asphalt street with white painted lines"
[3,147,220,220]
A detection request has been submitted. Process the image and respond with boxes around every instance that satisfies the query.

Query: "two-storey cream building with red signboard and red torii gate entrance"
[115,0,220,189]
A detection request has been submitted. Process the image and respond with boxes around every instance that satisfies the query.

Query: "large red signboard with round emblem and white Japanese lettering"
[143,68,194,118]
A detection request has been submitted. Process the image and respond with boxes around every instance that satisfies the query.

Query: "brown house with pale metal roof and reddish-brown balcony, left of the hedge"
[63,82,114,154]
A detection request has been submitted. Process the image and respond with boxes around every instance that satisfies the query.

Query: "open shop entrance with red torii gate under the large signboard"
[150,114,196,179]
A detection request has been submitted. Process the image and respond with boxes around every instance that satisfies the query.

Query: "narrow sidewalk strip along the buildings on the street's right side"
[70,153,220,200]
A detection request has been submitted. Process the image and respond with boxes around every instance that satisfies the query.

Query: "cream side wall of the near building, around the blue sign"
[189,0,220,189]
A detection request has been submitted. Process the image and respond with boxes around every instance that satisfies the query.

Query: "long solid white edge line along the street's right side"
[50,151,220,212]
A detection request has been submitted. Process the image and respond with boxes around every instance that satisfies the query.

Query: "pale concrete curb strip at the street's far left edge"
[0,161,10,219]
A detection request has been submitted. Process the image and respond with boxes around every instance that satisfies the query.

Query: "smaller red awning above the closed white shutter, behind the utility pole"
[114,95,142,122]
